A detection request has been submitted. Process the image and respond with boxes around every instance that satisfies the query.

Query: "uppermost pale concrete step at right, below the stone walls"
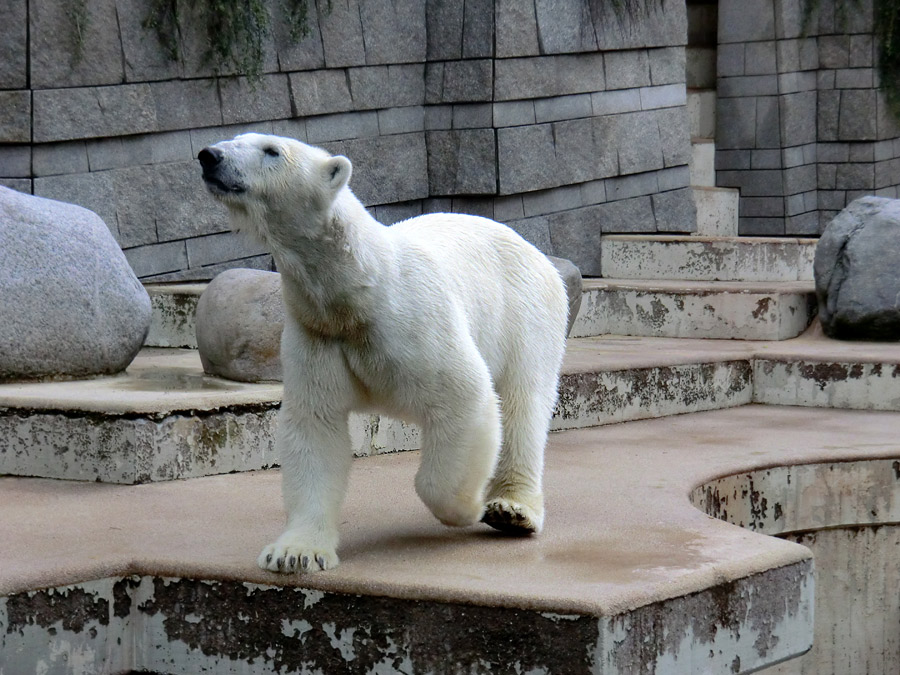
[600,234,818,282]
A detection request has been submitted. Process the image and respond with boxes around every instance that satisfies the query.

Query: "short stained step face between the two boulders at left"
[144,283,208,349]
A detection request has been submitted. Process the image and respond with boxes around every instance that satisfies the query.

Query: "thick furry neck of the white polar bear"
[268,188,391,339]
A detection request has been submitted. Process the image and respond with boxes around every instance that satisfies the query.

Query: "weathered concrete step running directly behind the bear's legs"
[0,338,752,484]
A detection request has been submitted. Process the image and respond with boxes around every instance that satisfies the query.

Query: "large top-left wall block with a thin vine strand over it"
[28,0,125,89]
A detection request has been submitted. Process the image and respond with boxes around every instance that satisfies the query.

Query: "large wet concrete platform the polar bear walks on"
[7,406,900,675]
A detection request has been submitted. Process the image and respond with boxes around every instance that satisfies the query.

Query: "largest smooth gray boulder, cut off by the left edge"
[0,187,150,381]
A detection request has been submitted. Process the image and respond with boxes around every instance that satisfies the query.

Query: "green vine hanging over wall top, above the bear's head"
[142,0,320,79]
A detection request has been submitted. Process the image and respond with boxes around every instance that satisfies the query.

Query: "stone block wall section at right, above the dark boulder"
[716,0,900,235]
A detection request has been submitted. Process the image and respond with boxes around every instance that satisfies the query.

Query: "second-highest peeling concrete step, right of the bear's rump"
[571,279,816,340]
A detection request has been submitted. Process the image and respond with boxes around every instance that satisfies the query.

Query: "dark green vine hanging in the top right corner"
[803,0,900,120]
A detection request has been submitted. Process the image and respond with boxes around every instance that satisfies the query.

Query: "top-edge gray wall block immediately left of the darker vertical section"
[359,0,427,64]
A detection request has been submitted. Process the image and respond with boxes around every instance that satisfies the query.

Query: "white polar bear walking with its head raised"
[198,134,567,572]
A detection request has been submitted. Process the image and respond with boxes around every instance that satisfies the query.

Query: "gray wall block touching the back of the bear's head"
[338,133,429,204]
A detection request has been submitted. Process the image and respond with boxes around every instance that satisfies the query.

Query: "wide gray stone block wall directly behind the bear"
[0,0,695,281]
